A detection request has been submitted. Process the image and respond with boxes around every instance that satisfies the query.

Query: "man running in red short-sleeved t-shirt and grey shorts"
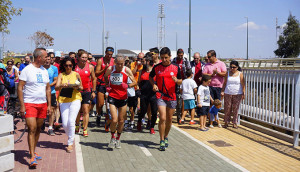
[149,47,182,151]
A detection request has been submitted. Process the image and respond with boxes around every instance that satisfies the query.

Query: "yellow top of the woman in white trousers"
[58,71,82,103]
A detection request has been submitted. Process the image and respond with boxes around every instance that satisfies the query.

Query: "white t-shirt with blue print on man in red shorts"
[19,64,49,104]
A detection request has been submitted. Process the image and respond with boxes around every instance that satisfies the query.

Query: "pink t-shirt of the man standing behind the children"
[202,60,227,88]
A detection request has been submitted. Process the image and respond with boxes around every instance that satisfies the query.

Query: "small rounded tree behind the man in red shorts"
[29,31,54,48]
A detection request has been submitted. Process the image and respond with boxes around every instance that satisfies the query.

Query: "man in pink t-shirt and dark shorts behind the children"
[202,50,227,100]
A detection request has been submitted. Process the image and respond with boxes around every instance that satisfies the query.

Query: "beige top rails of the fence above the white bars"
[225,58,300,70]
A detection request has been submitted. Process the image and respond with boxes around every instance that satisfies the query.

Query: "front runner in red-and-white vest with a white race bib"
[104,55,136,149]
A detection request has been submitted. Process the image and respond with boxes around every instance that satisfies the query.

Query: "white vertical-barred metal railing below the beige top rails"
[240,69,300,146]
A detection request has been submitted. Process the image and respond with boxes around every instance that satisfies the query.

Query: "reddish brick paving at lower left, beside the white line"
[13,121,77,172]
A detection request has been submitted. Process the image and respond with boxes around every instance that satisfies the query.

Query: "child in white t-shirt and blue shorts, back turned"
[179,69,197,125]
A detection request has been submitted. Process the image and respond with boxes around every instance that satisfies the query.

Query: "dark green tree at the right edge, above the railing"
[274,13,300,58]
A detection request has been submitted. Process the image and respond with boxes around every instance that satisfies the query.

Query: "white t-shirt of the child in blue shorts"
[180,79,197,100]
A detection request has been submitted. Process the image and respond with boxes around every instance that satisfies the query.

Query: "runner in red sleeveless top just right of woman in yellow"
[75,51,96,137]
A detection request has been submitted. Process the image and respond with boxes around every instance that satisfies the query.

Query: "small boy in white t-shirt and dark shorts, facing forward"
[197,75,213,131]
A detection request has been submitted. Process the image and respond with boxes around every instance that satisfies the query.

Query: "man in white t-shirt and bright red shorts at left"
[18,48,51,167]
